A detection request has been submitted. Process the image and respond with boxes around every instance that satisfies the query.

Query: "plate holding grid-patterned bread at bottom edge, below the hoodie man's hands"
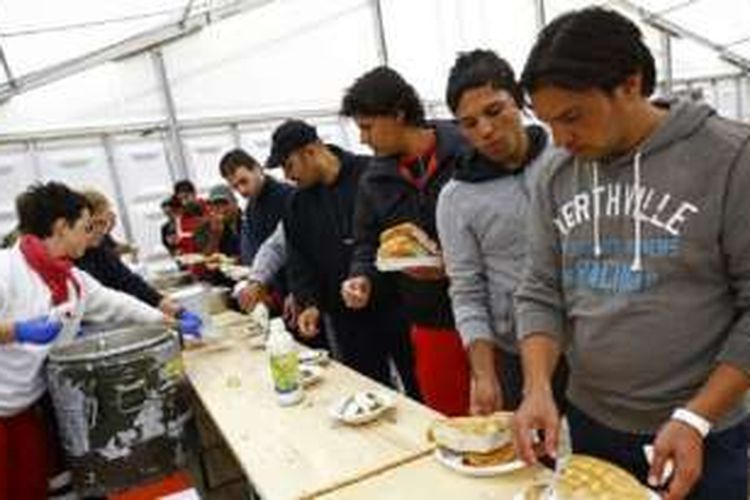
[514,454,660,500]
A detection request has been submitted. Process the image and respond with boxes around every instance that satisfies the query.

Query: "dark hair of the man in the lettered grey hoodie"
[521,7,656,97]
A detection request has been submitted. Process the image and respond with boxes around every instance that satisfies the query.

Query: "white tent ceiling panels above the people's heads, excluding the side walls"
[0,0,750,137]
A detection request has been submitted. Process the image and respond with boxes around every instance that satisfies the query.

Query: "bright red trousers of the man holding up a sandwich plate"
[411,325,470,417]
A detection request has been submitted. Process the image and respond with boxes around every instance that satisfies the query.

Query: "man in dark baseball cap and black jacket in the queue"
[266,120,418,396]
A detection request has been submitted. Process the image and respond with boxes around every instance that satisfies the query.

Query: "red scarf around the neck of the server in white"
[20,234,81,305]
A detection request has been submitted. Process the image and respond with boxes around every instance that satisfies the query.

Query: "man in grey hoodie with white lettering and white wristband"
[514,8,750,500]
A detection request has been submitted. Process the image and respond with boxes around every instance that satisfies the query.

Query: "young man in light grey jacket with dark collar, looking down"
[437,50,564,414]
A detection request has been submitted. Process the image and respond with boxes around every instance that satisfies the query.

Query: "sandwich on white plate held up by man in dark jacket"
[375,222,443,272]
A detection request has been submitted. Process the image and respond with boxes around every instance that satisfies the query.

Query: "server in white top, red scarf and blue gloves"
[0,182,199,500]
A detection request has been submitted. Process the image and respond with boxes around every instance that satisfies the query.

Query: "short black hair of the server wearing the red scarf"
[16,182,91,238]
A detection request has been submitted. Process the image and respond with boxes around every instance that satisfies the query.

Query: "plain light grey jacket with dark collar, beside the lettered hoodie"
[437,126,562,354]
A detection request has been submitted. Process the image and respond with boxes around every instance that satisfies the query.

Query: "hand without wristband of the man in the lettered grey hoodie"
[513,387,560,464]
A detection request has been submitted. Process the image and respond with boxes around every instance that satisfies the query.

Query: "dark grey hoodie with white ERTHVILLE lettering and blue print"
[516,98,750,433]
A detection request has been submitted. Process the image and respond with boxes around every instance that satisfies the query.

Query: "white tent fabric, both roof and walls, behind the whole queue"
[0,0,750,257]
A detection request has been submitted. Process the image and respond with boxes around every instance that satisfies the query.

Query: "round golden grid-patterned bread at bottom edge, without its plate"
[554,455,650,500]
